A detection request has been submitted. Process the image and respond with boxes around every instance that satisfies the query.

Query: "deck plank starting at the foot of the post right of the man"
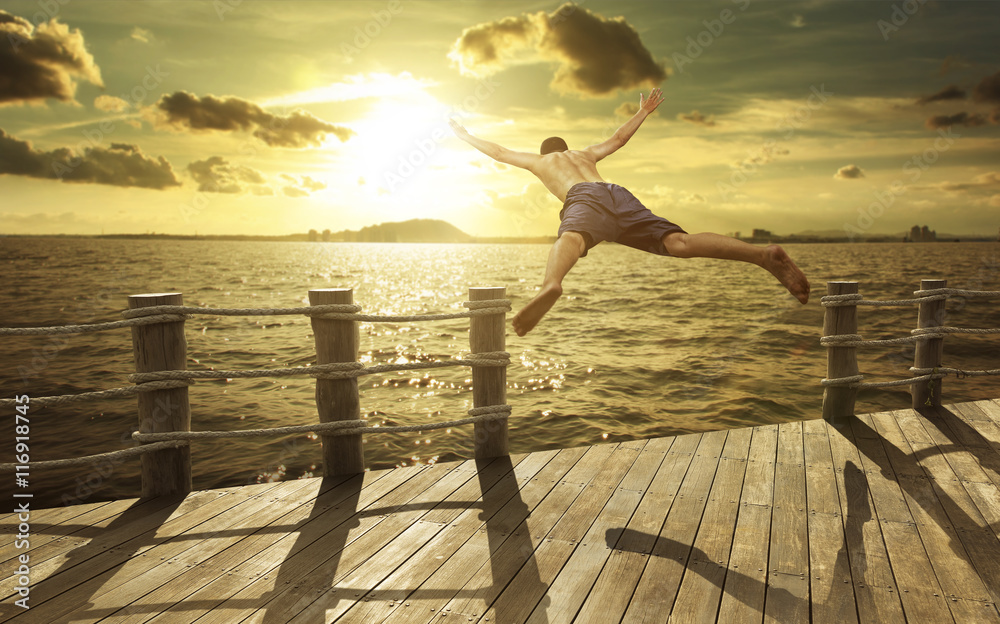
[828,412,905,624]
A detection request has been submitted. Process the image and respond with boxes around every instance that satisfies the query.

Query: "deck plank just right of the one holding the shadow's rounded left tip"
[622,431,727,623]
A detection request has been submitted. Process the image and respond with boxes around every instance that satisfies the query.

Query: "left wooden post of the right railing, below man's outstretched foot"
[823,282,858,427]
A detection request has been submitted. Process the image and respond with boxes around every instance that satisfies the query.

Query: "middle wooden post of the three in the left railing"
[309,288,365,477]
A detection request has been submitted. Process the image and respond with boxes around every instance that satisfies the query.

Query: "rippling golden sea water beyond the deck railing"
[0,238,1000,506]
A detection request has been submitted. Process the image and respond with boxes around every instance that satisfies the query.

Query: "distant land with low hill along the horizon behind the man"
[7,219,1000,244]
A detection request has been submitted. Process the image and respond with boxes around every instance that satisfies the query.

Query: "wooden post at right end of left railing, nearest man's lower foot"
[469,287,509,459]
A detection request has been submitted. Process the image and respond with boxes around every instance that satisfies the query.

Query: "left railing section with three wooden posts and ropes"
[0,288,511,496]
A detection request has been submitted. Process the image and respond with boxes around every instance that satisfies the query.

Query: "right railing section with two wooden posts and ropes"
[820,280,1000,421]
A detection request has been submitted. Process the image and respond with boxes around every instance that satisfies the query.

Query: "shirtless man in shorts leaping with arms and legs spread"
[451,89,809,336]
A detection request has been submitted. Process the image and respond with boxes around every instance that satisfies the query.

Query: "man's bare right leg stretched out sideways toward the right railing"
[663,232,809,303]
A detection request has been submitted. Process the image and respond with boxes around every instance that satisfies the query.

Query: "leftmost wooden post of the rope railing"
[128,293,191,498]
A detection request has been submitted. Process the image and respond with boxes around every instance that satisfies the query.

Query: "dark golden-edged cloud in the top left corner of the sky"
[0,10,104,106]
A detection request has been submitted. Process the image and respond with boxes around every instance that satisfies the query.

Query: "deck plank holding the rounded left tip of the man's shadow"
[578,434,701,622]
